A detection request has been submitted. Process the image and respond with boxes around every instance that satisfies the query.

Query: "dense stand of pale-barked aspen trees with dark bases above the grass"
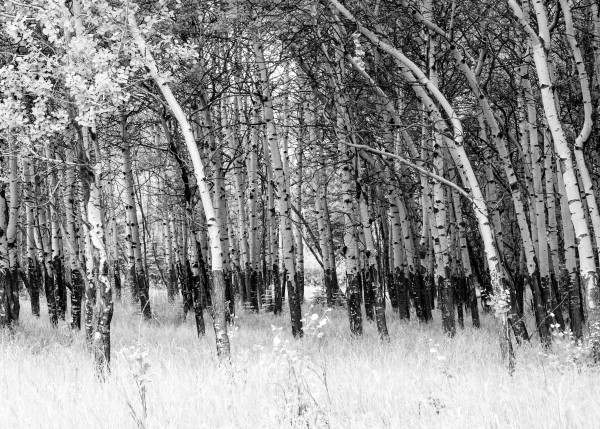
[0,0,600,426]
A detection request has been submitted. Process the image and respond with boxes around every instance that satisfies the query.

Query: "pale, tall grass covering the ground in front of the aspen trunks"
[0,294,600,429]
